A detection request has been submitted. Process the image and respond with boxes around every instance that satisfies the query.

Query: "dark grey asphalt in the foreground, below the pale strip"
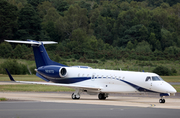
[0,101,180,118]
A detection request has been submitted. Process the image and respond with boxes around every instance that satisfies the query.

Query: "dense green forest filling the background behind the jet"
[0,0,180,60]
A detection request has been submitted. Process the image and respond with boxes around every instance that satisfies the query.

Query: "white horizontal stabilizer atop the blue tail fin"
[4,40,57,45]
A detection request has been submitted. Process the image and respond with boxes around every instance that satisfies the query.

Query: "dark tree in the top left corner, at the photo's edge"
[0,0,18,42]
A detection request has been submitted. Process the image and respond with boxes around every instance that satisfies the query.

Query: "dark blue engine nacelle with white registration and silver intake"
[37,66,67,79]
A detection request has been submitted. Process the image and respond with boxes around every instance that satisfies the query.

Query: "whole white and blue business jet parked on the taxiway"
[5,40,177,103]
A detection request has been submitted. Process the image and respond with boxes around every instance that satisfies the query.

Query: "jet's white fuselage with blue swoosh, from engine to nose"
[52,67,176,93]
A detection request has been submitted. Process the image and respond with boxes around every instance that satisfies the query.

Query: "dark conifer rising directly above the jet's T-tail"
[16,4,41,40]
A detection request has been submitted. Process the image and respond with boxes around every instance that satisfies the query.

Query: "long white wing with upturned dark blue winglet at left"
[6,69,101,91]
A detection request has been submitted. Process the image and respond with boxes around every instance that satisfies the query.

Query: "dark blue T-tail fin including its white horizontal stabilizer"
[5,40,66,68]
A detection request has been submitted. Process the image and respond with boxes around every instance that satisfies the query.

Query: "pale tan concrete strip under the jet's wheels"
[0,92,180,109]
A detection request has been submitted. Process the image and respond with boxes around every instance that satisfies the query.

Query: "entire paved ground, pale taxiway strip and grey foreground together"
[0,92,180,118]
